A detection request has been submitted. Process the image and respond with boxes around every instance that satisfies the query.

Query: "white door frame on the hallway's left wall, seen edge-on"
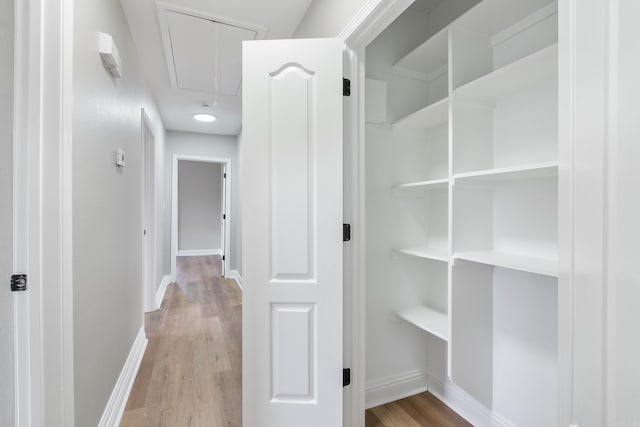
[140,108,158,312]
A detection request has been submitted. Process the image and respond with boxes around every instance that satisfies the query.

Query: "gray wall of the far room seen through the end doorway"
[178,160,223,251]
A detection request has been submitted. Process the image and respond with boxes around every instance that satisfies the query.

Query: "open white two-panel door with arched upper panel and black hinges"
[242,39,344,427]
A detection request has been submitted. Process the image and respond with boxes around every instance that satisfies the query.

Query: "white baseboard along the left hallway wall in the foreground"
[98,326,147,427]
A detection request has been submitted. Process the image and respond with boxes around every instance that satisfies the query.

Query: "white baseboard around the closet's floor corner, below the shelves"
[365,370,514,427]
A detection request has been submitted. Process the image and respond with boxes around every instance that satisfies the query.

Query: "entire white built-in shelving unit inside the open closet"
[380,0,559,426]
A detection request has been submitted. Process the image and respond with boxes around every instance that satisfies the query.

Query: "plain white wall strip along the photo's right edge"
[608,2,640,426]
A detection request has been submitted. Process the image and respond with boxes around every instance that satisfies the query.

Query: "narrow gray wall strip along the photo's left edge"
[0,0,14,426]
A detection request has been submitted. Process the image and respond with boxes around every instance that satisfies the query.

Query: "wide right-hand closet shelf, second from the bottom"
[453,162,558,186]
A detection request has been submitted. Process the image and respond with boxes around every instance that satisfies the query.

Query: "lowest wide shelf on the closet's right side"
[453,251,558,277]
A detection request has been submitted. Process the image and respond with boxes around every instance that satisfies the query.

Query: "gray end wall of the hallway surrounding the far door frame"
[163,131,242,274]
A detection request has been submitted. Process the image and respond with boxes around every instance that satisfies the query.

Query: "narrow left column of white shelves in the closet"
[392,23,451,342]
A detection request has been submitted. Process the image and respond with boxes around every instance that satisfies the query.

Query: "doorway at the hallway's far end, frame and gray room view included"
[171,154,231,278]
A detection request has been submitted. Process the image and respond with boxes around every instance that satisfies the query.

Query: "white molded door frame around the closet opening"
[339,0,576,427]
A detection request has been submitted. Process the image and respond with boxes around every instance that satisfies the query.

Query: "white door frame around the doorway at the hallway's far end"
[171,154,232,280]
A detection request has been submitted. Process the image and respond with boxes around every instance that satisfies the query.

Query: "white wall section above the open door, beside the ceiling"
[293,0,367,38]
